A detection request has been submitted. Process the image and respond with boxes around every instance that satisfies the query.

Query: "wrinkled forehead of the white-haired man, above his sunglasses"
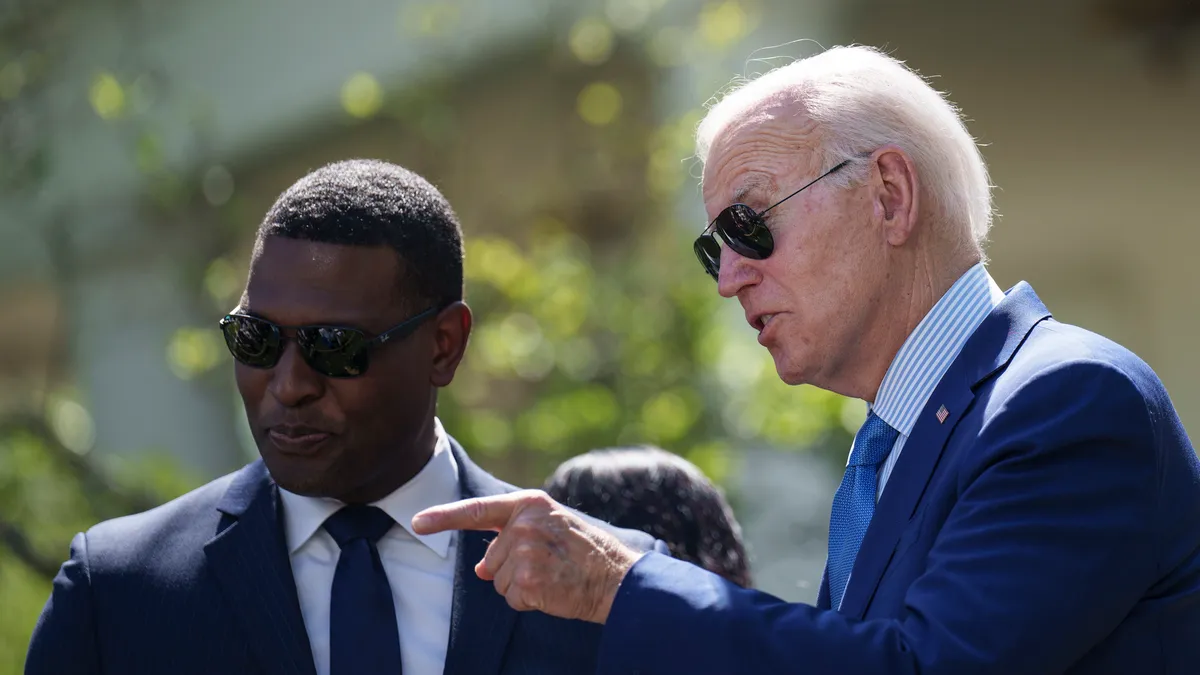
[703,104,816,211]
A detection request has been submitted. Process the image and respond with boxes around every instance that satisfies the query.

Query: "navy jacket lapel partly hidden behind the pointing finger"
[443,438,517,675]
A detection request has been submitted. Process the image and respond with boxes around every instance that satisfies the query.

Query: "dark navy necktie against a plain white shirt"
[325,506,402,675]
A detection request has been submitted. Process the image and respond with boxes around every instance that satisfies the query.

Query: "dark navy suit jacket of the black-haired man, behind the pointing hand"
[25,432,666,675]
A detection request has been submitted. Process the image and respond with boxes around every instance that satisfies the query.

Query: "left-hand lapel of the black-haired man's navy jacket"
[204,461,316,675]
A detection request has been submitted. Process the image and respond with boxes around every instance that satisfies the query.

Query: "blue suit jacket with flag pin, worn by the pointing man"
[599,283,1200,675]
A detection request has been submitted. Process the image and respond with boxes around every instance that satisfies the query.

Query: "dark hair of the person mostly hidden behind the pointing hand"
[544,446,751,587]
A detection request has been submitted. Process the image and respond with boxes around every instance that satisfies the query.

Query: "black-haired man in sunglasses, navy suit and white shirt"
[25,161,666,675]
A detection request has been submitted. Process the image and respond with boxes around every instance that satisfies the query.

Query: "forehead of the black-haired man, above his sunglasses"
[242,237,401,327]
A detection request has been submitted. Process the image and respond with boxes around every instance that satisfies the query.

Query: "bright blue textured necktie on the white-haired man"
[827,412,900,609]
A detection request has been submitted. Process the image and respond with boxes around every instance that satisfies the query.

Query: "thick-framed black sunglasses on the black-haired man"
[220,306,442,377]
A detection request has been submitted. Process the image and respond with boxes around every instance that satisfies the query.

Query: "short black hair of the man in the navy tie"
[258,160,463,305]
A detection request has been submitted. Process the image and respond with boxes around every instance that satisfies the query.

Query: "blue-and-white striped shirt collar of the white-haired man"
[871,263,1004,436]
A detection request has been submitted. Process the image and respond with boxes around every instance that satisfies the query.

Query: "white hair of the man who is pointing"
[696,46,992,251]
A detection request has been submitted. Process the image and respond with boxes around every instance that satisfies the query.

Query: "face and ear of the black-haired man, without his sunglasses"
[236,237,453,503]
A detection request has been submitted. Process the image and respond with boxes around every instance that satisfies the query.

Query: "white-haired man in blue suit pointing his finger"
[414,47,1200,675]
